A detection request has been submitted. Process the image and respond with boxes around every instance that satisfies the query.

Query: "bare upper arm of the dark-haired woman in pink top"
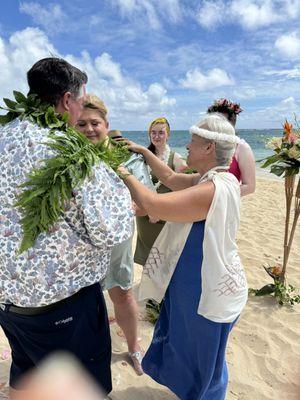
[236,143,255,196]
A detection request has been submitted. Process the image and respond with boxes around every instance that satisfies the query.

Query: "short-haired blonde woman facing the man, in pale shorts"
[76,94,143,375]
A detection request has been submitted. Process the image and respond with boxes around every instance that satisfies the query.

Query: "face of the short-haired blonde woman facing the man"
[76,108,108,144]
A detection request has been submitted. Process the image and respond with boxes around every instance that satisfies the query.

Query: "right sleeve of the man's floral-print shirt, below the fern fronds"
[80,163,133,247]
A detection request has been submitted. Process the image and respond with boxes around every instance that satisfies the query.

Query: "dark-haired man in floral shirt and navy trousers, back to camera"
[0,58,132,393]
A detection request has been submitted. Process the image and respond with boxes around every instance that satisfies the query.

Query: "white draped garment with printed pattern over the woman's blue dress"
[139,170,248,323]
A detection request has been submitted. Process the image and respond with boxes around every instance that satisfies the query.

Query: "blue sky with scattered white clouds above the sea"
[0,0,300,130]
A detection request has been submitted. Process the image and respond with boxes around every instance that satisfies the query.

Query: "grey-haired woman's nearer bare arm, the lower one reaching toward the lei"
[120,174,215,222]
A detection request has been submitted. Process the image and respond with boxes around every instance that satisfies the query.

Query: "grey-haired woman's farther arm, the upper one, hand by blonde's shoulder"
[126,140,200,190]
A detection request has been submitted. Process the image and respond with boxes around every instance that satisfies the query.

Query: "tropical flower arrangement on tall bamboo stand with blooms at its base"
[250,120,300,305]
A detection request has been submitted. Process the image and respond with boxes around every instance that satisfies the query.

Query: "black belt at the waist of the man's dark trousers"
[0,286,91,315]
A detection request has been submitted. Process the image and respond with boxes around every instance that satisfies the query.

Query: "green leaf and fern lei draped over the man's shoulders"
[0,91,130,254]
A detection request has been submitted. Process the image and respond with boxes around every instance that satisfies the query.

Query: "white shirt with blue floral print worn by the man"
[0,120,133,307]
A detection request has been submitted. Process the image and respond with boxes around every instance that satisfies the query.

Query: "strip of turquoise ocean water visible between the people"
[123,129,282,166]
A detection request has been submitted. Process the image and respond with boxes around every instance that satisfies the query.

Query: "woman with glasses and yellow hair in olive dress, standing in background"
[134,117,187,265]
